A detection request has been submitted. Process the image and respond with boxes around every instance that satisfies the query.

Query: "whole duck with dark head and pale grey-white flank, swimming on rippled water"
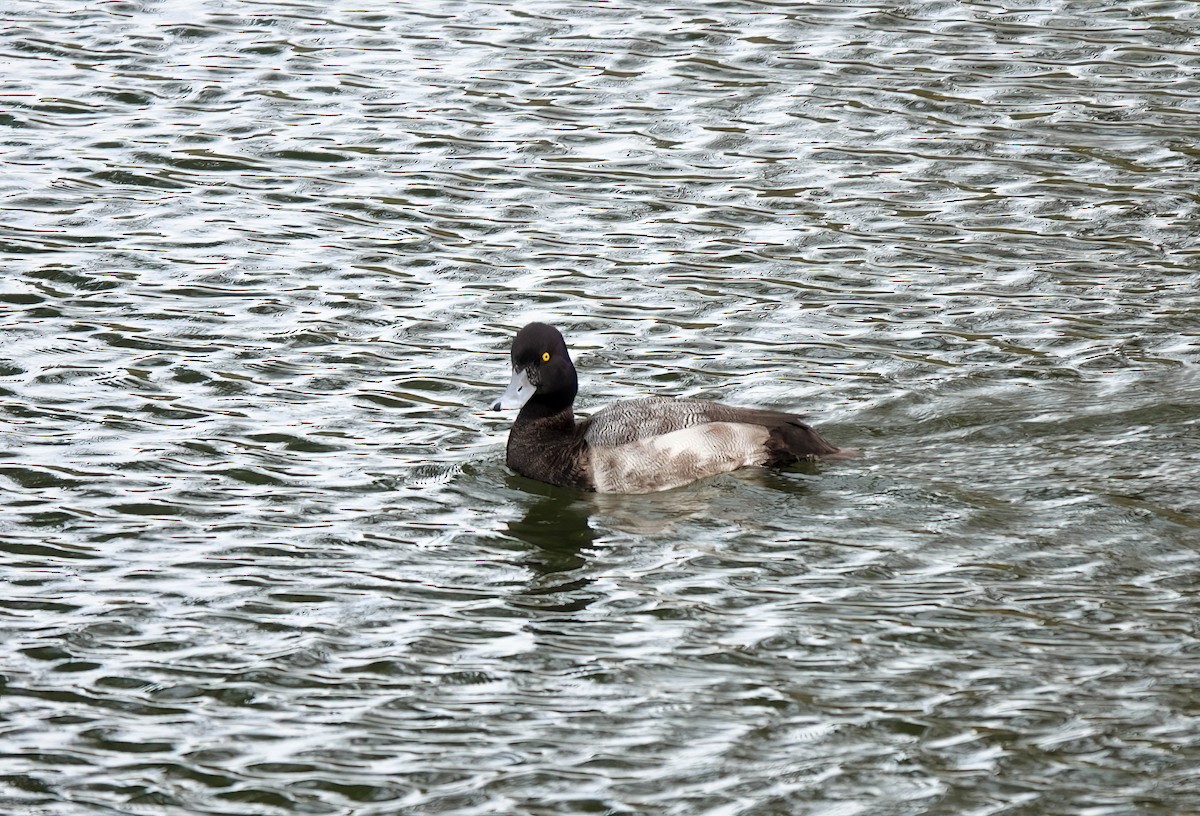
[492,323,856,493]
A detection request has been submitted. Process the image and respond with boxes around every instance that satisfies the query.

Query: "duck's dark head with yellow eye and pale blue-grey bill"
[492,323,580,416]
